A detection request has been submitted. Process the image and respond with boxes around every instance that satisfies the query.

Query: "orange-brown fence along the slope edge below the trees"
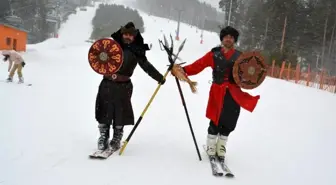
[267,61,336,93]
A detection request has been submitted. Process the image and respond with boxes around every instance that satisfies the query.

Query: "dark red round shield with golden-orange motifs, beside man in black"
[88,38,123,75]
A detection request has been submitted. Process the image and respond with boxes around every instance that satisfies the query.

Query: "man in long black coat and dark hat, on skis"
[96,22,165,150]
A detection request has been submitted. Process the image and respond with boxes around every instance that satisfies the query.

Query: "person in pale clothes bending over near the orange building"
[2,50,25,83]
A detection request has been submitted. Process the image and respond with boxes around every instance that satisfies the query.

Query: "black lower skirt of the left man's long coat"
[95,79,134,128]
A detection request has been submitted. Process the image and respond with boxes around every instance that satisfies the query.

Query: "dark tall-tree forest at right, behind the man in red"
[239,0,336,74]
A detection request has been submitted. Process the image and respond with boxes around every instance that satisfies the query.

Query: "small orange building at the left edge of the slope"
[0,23,28,51]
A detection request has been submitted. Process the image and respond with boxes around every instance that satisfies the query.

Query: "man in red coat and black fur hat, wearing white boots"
[173,26,260,162]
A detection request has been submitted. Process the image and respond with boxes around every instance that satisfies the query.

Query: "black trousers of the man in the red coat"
[208,90,240,136]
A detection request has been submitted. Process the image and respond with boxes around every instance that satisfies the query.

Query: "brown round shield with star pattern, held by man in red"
[232,51,267,89]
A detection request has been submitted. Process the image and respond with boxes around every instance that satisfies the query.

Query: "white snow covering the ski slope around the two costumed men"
[0,2,336,185]
